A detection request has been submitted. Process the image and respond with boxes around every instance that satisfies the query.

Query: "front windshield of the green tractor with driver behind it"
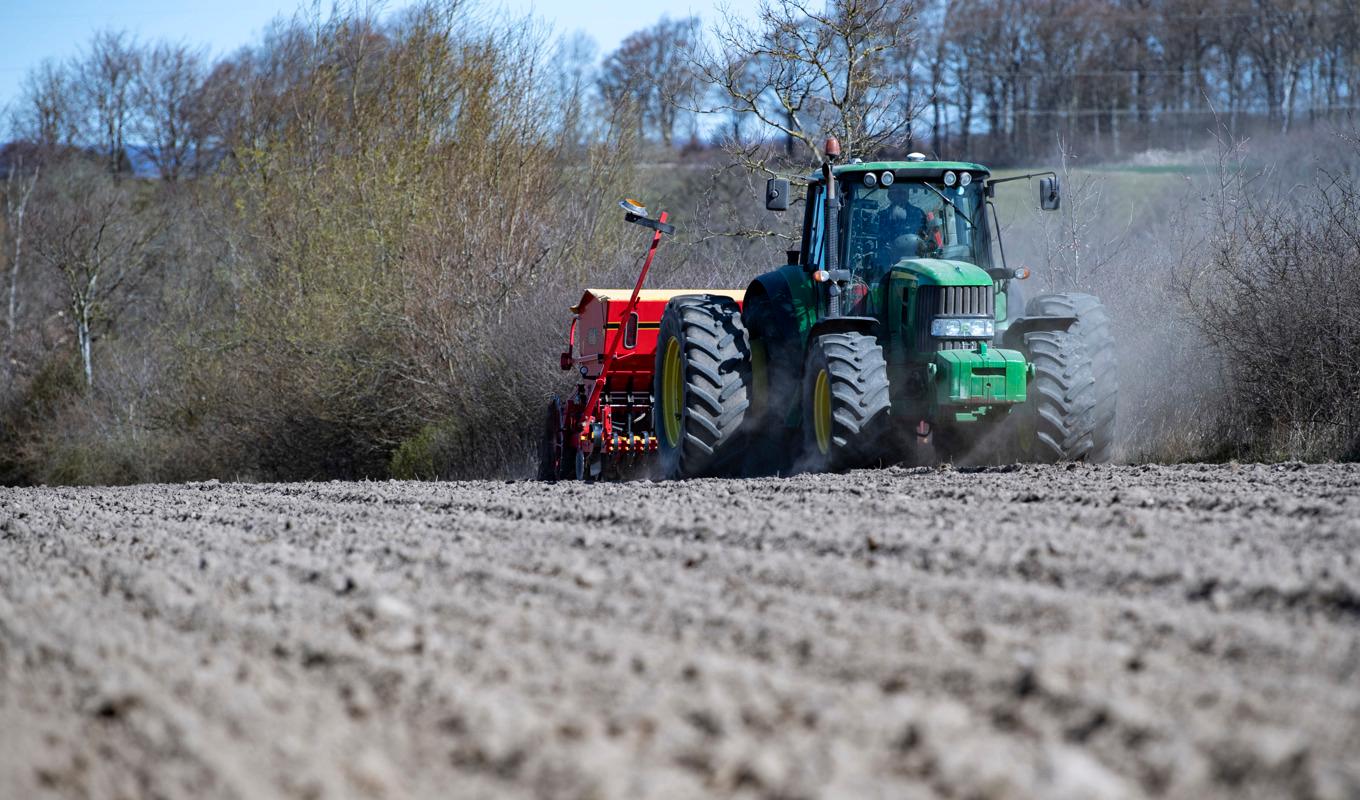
[843,181,991,283]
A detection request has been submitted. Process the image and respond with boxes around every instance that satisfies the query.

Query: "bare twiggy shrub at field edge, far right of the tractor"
[1190,134,1360,460]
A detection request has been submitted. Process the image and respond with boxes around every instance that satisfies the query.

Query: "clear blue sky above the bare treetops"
[0,0,758,114]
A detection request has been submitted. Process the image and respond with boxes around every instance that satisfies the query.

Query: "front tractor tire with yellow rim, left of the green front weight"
[801,333,891,472]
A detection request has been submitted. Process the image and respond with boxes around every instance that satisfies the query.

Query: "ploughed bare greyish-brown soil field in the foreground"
[0,464,1360,799]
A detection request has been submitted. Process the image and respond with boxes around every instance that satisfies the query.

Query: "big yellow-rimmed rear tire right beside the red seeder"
[651,295,751,479]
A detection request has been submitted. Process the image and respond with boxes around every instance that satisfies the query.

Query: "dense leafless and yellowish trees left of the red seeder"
[0,1,647,482]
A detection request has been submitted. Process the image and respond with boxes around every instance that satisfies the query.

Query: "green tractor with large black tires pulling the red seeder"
[651,141,1118,478]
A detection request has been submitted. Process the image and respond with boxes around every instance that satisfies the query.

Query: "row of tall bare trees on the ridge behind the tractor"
[600,0,1360,165]
